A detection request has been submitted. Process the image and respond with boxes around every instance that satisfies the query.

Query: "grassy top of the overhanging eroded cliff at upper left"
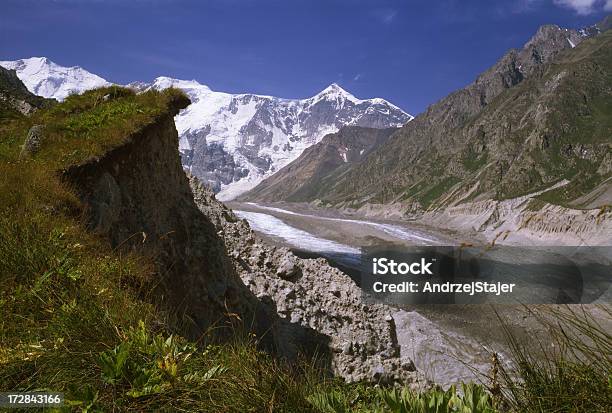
[0,86,187,170]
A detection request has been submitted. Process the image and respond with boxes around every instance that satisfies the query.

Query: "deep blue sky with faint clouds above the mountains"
[0,0,612,114]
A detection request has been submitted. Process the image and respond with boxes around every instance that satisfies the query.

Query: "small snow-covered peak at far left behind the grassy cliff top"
[0,57,110,100]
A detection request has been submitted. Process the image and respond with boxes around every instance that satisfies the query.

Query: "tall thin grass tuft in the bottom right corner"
[501,306,612,413]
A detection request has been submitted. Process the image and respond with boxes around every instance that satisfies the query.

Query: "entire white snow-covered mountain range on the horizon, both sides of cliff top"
[0,57,412,200]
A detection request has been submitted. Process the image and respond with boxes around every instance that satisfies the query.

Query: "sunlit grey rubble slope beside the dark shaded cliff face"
[189,176,428,387]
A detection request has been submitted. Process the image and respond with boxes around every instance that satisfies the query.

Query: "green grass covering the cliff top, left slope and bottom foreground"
[0,87,610,413]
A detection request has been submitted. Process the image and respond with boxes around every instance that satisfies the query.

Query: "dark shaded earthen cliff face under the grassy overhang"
[64,97,264,334]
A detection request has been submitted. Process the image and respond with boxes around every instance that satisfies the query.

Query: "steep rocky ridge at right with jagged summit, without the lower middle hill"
[247,19,609,211]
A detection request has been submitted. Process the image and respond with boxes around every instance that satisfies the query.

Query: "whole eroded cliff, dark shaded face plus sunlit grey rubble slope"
[58,92,424,385]
